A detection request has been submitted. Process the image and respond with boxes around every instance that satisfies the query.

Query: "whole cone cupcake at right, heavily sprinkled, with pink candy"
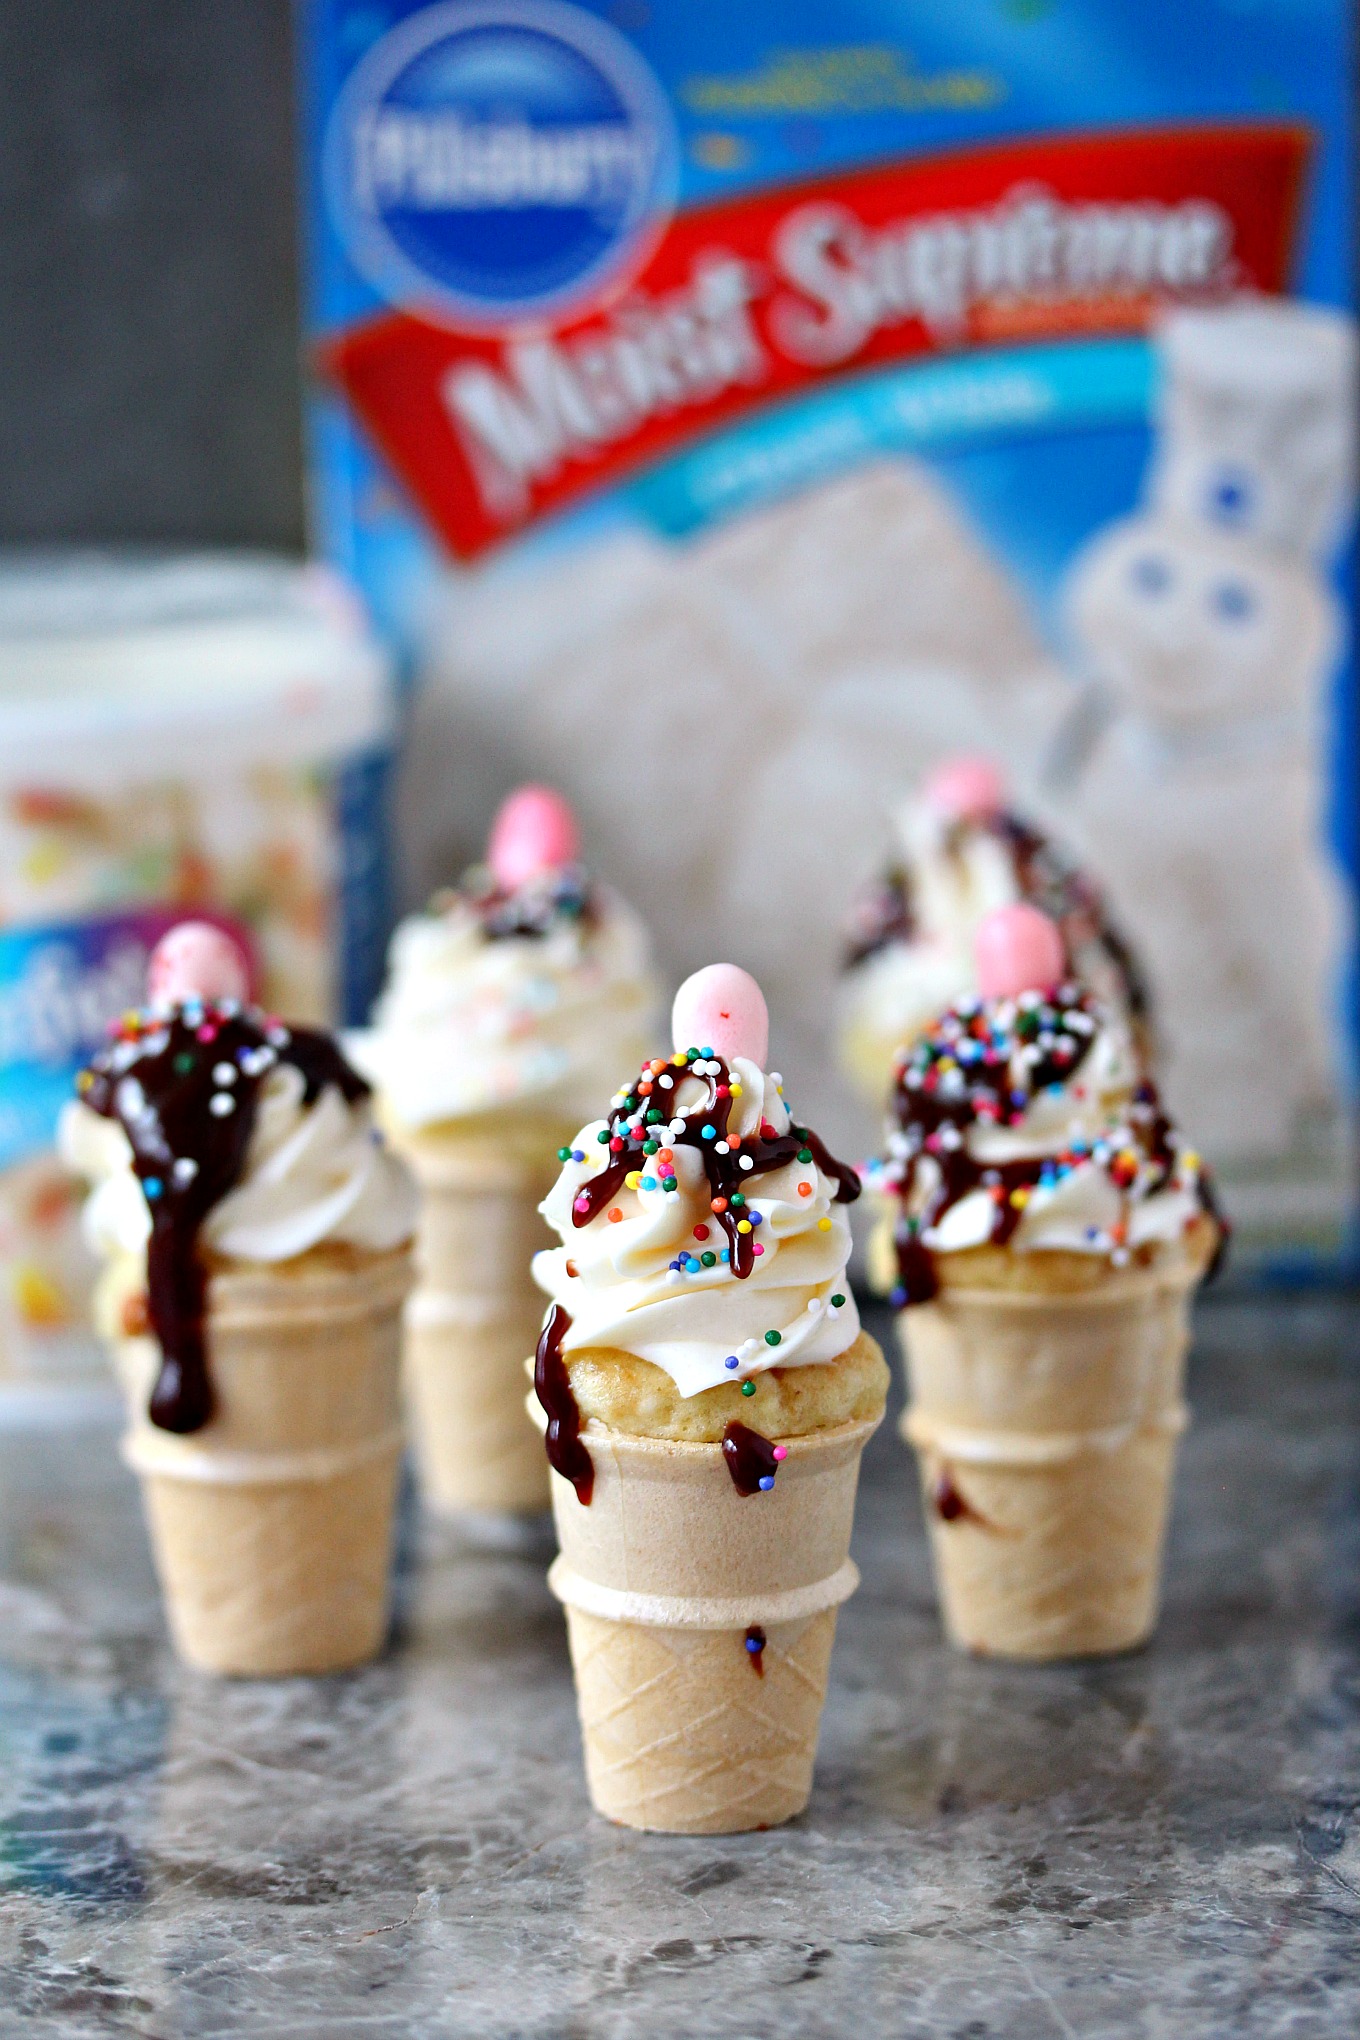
[871,906,1225,1659]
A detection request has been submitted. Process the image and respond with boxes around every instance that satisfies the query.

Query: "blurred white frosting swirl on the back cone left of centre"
[345,889,657,1128]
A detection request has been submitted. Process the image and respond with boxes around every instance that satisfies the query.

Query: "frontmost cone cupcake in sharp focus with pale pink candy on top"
[534,965,887,1834]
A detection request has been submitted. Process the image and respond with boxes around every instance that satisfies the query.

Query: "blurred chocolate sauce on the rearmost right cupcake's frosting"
[844,814,1152,1026]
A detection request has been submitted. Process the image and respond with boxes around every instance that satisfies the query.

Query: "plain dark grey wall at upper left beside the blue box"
[0,0,304,553]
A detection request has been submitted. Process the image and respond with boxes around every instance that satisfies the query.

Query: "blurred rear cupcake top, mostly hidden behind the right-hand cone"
[840,757,1150,1112]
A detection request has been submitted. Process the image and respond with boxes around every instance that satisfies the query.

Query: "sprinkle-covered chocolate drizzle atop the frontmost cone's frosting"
[571,1049,860,1281]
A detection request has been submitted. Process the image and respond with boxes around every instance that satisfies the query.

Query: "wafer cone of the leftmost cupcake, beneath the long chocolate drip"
[120,1251,410,1677]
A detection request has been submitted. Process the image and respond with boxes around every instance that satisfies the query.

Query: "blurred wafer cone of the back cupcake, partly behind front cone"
[394,1126,571,1514]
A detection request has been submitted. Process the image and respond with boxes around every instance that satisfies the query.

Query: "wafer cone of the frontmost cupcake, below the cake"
[548,1420,877,1834]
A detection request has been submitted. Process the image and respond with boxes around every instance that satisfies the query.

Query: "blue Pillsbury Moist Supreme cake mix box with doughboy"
[304,0,1356,1271]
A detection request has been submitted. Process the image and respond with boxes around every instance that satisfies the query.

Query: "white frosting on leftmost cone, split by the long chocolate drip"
[59,1063,418,1261]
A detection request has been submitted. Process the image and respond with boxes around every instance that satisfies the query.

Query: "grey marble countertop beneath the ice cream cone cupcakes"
[0,1295,1360,2040]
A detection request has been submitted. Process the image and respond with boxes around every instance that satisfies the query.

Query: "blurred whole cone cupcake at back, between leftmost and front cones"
[347,785,657,1512]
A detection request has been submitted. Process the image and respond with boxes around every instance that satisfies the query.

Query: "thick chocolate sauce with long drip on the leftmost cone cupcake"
[77,1002,369,1434]
